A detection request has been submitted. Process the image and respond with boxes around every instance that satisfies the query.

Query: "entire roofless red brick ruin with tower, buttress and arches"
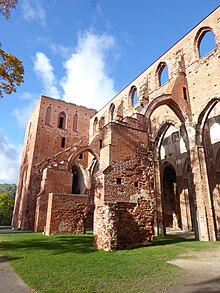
[12,7,220,250]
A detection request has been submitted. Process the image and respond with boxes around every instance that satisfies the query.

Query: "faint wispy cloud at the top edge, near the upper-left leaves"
[21,0,46,25]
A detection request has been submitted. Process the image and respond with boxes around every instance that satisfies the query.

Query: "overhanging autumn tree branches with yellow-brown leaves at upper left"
[0,0,24,98]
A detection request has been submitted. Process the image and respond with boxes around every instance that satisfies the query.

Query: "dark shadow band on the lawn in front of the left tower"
[0,234,96,254]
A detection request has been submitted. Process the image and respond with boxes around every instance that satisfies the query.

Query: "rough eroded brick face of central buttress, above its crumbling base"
[104,144,154,202]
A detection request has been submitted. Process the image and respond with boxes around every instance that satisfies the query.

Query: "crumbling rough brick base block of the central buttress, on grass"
[94,199,155,250]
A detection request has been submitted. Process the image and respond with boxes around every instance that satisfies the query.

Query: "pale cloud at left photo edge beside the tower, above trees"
[0,132,22,184]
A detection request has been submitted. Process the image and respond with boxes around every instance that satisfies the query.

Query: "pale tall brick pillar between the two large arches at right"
[190,146,216,241]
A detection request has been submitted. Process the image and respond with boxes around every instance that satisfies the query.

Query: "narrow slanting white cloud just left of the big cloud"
[34,52,60,99]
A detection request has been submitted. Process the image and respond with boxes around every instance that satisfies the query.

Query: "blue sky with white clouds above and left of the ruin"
[0,0,220,183]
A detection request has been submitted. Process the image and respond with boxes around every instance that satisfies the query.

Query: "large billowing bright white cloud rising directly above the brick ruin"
[61,32,116,109]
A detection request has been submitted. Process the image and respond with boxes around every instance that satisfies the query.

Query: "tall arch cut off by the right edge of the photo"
[197,97,220,235]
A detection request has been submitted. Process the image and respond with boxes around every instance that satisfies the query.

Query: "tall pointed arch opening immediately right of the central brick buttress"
[145,97,195,233]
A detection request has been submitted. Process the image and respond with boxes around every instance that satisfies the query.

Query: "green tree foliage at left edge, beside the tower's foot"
[0,192,14,226]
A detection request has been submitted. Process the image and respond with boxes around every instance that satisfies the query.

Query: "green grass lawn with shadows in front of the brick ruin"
[0,233,220,293]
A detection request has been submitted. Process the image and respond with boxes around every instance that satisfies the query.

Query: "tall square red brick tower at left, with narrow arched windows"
[12,96,96,229]
